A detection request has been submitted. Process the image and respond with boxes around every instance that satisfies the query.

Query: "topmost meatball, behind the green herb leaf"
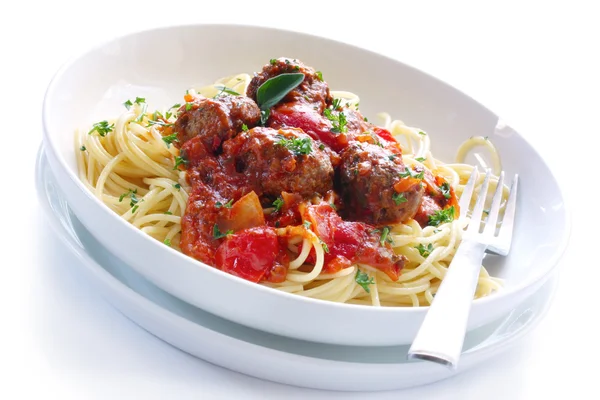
[246,57,333,114]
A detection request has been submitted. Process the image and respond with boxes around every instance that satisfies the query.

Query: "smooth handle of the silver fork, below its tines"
[408,239,487,369]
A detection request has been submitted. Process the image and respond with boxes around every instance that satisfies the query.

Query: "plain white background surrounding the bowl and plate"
[0,0,600,399]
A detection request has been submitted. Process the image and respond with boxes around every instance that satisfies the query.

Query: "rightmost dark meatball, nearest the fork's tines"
[338,142,425,225]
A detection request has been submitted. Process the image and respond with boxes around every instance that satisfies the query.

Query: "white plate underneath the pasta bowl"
[36,147,557,391]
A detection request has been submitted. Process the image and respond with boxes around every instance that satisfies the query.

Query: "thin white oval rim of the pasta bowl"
[42,23,571,314]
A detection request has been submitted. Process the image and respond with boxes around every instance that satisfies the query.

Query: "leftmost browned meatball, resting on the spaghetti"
[173,96,260,153]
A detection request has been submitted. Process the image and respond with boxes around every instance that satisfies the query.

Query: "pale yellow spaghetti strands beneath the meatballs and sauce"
[75,65,501,306]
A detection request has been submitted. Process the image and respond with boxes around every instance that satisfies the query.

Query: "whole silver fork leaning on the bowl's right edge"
[408,168,519,369]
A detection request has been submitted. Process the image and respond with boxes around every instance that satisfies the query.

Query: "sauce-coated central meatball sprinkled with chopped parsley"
[223,127,334,198]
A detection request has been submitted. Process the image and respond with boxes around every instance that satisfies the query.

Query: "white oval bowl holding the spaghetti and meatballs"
[43,25,570,346]
